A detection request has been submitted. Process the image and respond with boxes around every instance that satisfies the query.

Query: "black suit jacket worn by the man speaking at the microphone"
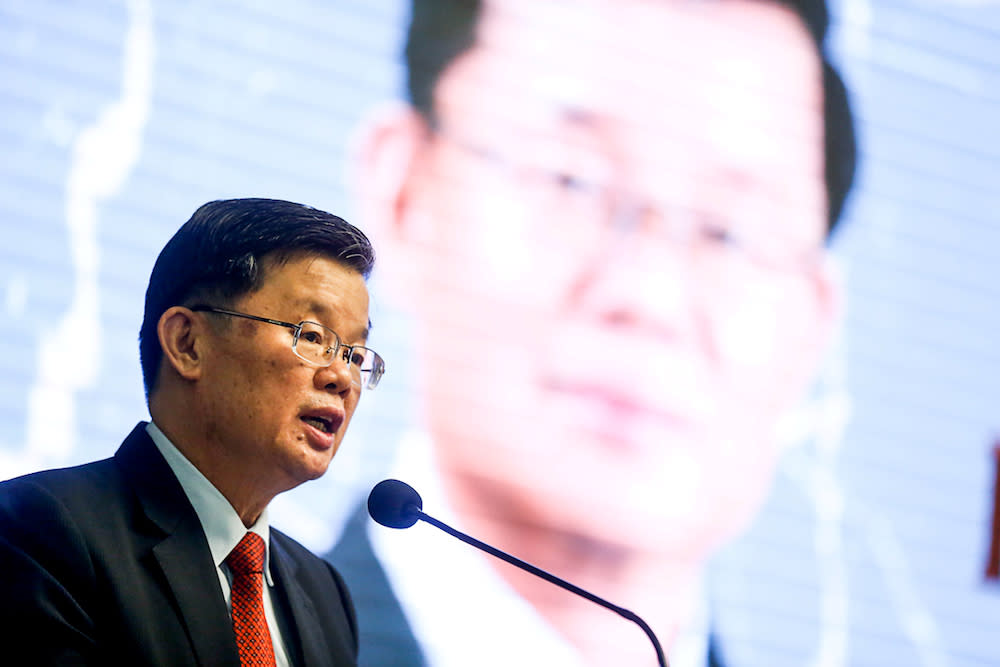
[0,423,358,667]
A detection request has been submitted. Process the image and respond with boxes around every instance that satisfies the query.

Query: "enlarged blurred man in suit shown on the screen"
[329,0,854,667]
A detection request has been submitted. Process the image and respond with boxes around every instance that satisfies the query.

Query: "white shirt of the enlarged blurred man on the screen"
[368,434,708,667]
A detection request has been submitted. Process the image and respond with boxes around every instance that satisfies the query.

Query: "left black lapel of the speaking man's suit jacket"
[115,423,240,667]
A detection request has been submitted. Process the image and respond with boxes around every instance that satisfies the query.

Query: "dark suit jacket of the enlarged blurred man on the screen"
[326,506,725,667]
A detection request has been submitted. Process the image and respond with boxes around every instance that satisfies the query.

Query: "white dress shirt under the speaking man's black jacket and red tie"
[146,422,290,667]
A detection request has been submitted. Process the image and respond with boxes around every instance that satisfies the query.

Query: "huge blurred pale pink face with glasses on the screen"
[367,0,834,557]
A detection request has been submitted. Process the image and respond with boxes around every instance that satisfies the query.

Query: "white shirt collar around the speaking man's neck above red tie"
[146,422,274,586]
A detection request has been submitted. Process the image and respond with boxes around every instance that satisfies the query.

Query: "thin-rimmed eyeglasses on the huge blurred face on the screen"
[432,126,822,274]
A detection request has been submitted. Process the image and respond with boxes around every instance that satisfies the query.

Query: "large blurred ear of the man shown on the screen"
[352,104,433,304]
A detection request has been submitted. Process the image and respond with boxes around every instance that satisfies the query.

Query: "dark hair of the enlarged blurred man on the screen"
[405,0,857,235]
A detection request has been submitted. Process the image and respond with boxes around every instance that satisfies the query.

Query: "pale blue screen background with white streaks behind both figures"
[0,0,1000,666]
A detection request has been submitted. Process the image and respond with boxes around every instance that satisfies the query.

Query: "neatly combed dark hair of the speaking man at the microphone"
[139,199,375,399]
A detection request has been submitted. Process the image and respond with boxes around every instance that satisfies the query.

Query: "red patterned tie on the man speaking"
[226,533,274,667]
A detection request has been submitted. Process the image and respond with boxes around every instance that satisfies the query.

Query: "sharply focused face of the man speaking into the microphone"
[193,255,368,493]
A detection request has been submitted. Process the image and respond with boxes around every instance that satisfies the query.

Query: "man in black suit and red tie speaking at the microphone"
[0,199,384,667]
